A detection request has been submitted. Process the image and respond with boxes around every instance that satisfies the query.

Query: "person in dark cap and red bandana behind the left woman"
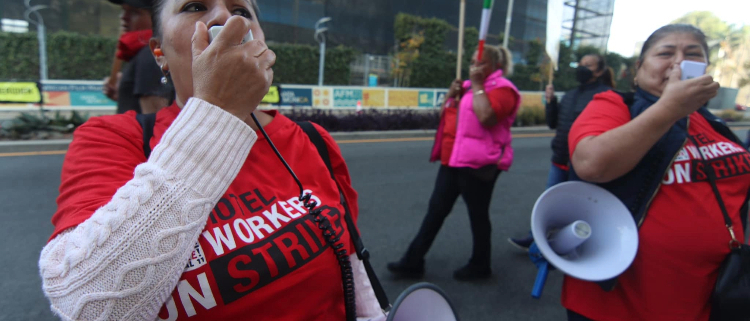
[103,0,172,114]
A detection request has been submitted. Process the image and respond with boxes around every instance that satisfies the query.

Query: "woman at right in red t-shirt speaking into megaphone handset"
[562,25,750,321]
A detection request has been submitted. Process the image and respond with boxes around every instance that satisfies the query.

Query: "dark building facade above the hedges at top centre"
[258,0,547,55]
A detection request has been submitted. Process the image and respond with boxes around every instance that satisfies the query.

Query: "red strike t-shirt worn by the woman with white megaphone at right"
[562,91,750,321]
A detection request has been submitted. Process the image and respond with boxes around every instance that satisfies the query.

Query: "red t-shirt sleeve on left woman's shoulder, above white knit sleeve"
[50,112,146,240]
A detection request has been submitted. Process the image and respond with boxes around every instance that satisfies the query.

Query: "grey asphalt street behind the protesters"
[0,128,744,321]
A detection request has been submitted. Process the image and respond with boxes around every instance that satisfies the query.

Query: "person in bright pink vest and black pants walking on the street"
[388,46,521,280]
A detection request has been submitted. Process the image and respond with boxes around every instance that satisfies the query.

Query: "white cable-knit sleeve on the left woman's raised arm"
[39,98,257,321]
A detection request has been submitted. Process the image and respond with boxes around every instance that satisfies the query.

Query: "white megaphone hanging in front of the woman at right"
[531,182,638,297]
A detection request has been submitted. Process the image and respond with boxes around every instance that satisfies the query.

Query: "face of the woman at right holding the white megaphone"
[635,33,708,97]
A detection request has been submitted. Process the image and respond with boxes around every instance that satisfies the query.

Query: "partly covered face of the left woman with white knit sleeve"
[152,0,265,105]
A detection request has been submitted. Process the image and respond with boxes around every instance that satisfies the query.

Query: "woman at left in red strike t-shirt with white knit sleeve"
[39,0,385,321]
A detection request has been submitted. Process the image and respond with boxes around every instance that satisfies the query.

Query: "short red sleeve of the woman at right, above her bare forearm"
[568,91,630,156]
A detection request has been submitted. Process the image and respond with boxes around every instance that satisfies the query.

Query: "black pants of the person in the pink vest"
[404,165,500,267]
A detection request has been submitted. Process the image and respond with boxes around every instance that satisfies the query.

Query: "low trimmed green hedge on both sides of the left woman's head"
[0,32,358,85]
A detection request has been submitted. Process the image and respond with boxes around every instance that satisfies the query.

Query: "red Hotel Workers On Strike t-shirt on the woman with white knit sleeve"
[52,106,358,321]
